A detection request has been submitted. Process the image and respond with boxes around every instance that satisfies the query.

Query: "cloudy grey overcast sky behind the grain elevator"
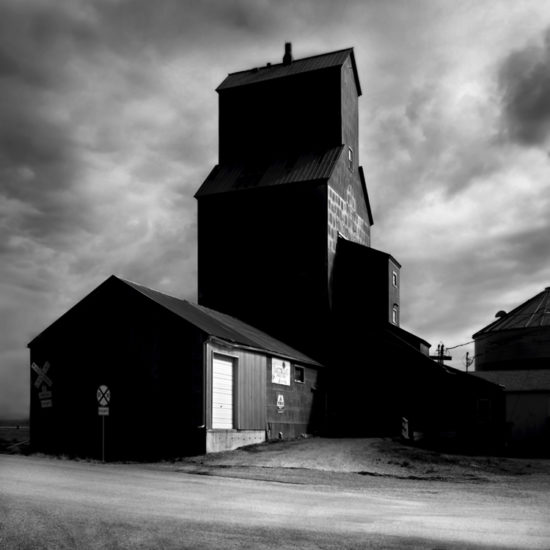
[0,0,550,417]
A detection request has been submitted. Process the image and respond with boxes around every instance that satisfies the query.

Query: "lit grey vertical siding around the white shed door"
[206,341,267,436]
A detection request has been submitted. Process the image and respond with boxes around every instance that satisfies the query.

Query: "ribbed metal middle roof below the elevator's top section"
[195,145,344,198]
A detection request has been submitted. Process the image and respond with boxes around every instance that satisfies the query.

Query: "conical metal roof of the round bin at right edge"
[472,287,550,338]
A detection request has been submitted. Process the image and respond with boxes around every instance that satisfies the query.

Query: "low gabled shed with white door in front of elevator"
[29,276,325,460]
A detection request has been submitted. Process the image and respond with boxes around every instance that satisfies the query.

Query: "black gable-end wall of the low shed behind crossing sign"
[30,280,204,460]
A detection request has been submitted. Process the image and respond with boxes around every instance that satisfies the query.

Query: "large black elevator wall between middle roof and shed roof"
[202,183,329,360]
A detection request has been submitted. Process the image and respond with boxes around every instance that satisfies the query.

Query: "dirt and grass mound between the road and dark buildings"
[162,437,550,483]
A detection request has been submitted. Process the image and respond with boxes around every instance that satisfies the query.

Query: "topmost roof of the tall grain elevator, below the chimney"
[216,48,361,96]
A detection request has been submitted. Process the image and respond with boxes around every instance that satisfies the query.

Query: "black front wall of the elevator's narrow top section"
[219,67,342,163]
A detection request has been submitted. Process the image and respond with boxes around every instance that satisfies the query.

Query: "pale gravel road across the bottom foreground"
[0,455,550,549]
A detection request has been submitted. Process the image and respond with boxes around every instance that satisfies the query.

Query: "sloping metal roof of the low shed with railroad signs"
[118,276,322,366]
